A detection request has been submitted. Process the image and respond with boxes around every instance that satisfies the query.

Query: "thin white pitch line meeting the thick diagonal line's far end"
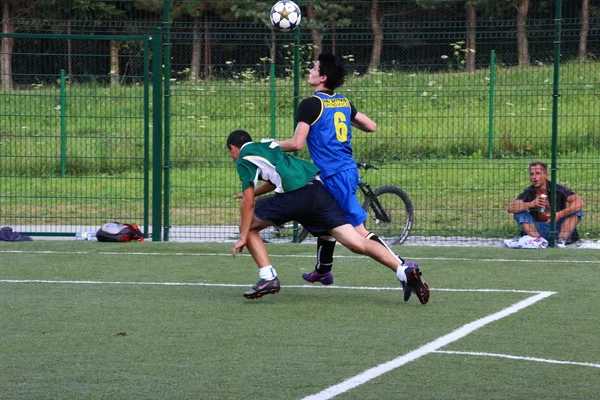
[0,279,554,294]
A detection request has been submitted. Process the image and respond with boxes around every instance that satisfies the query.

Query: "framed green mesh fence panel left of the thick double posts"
[0,34,161,236]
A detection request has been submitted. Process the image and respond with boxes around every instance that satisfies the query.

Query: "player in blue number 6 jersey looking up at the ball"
[279,53,419,301]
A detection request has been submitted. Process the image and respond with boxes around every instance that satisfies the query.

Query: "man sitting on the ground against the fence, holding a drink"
[507,161,584,248]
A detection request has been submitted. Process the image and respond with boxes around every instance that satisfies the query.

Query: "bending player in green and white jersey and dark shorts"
[227,130,429,304]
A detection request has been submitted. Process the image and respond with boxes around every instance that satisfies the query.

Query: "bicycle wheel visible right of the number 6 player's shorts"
[362,186,414,245]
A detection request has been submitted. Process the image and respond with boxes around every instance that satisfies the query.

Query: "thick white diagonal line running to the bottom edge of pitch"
[303,292,555,400]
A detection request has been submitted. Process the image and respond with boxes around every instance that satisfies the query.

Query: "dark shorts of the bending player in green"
[254,180,349,236]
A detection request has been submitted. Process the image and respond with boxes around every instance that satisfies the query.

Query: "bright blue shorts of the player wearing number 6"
[323,168,367,226]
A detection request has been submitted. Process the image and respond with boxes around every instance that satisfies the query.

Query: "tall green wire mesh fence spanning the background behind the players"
[0,1,600,244]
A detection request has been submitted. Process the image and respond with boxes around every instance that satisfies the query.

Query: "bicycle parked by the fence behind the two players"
[257,162,414,245]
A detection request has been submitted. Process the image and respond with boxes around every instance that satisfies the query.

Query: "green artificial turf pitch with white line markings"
[0,241,600,400]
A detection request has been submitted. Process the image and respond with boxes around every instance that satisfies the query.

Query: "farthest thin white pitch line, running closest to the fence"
[0,250,600,264]
